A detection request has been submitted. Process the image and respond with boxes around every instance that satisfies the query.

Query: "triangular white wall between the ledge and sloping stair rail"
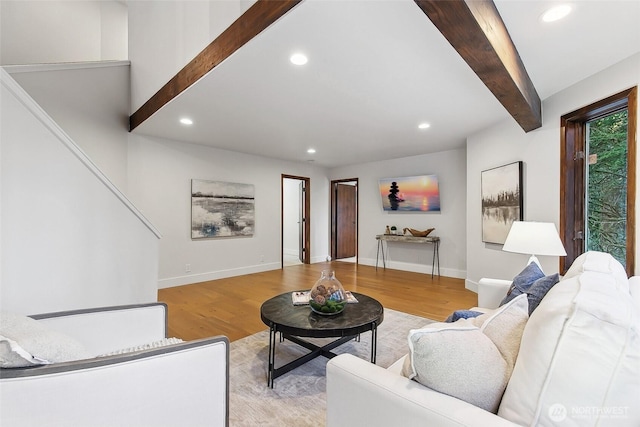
[5,61,129,191]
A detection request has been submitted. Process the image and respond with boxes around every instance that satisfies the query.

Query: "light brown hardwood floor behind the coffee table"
[158,261,477,341]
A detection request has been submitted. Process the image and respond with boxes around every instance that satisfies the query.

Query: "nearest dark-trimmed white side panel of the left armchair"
[0,337,229,426]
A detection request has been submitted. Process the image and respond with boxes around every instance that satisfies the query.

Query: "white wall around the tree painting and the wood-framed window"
[467,55,640,289]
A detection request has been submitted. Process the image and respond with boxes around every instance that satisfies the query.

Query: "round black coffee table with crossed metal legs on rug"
[260,292,384,388]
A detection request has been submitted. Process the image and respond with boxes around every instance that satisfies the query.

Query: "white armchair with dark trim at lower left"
[0,303,229,427]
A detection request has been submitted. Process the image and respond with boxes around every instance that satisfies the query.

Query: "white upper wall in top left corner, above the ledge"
[0,0,128,65]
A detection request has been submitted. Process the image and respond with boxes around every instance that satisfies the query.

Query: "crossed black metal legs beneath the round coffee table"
[267,323,378,388]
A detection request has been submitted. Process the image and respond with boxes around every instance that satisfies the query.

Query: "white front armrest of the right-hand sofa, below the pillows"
[326,354,515,427]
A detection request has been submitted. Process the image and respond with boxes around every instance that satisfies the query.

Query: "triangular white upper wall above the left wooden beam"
[128,0,254,112]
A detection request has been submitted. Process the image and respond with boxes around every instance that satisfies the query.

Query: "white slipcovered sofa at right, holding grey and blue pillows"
[327,252,640,427]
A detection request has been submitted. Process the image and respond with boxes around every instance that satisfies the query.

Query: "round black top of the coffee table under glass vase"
[260,292,384,338]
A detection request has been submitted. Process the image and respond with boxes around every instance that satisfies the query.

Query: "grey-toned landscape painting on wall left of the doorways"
[191,179,255,239]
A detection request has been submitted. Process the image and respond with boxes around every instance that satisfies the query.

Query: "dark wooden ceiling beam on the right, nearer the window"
[415,0,542,132]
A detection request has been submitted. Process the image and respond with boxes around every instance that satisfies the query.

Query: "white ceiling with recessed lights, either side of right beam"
[134,0,640,168]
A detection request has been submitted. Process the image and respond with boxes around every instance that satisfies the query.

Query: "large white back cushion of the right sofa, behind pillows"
[498,252,640,426]
